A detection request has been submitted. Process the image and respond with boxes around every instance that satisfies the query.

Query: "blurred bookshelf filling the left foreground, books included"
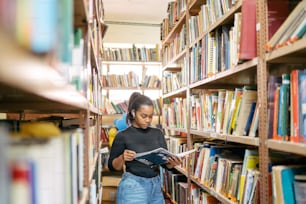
[0,0,107,203]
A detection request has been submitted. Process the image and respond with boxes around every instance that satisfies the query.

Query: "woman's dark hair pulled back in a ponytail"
[126,92,153,124]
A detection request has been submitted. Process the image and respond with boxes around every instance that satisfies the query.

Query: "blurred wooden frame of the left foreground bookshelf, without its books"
[0,1,105,203]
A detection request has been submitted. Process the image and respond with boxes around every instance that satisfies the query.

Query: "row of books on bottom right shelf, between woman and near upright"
[191,142,259,203]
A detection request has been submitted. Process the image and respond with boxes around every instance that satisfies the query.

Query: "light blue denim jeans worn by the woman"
[116,172,165,204]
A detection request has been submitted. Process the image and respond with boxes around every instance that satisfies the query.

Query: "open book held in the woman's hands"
[135,147,196,165]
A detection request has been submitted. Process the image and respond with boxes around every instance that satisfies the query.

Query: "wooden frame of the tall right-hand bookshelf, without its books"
[162,0,306,204]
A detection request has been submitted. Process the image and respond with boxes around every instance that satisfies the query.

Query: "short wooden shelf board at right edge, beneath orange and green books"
[266,139,306,156]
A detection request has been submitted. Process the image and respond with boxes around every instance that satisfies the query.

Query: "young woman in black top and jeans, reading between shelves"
[108,93,180,204]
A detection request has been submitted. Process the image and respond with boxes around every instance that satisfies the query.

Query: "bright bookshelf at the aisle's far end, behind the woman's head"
[100,43,161,124]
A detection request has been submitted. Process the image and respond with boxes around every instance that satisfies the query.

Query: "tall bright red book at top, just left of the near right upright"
[239,0,257,60]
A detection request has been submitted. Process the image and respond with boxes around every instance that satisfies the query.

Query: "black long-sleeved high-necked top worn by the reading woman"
[108,126,167,178]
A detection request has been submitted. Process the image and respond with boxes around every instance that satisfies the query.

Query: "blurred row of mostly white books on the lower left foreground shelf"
[0,121,85,204]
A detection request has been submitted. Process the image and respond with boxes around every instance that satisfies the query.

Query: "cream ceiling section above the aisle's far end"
[103,0,170,24]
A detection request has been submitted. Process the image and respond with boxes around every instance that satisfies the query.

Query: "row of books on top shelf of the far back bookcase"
[102,44,160,62]
